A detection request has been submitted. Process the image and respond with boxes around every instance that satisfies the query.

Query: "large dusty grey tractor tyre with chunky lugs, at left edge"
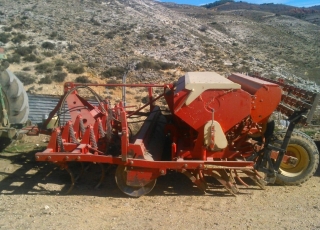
[0,70,29,124]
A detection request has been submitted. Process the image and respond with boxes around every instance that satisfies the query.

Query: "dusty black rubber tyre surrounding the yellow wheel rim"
[275,130,319,185]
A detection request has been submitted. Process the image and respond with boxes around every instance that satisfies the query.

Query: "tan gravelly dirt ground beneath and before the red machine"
[0,137,320,229]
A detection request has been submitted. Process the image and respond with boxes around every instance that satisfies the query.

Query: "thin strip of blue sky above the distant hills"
[160,0,320,7]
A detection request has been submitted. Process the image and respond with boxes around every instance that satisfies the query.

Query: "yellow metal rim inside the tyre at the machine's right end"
[280,144,310,177]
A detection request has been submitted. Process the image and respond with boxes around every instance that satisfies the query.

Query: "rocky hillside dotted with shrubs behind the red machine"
[0,0,320,97]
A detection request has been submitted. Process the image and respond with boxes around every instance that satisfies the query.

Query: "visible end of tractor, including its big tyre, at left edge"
[0,47,29,150]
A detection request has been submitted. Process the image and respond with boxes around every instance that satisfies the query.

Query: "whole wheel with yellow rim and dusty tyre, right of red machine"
[273,131,319,185]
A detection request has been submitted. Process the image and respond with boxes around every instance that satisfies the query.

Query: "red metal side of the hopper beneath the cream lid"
[174,86,251,132]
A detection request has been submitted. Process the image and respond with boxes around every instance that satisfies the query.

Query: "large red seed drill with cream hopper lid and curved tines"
[26,72,319,197]
